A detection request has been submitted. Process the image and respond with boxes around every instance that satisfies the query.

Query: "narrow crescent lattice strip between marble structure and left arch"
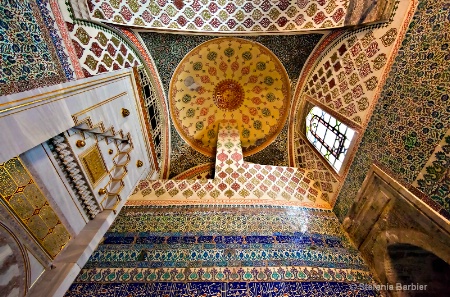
[139,67,163,166]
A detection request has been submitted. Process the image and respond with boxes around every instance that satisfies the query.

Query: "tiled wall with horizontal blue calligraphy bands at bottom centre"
[65,206,377,297]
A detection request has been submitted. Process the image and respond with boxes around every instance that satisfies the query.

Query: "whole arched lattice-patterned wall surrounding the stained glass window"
[289,0,417,205]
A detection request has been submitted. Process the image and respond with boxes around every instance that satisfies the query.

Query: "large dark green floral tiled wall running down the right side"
[335,0,450,219]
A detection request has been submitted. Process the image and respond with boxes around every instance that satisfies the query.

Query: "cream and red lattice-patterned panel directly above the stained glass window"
[301,0,409,126]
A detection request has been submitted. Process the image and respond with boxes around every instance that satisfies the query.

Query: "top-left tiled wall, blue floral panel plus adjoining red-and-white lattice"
[0,0,142,89]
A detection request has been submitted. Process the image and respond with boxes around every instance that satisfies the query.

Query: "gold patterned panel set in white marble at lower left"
[0,158,70,258]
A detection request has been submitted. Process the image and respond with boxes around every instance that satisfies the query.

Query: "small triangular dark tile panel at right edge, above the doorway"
[412,129,450,215]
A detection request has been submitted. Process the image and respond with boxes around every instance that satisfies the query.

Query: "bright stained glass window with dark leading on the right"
[306,106,355,172]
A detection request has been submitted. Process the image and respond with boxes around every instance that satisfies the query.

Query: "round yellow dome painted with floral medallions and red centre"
[169,38,290,156]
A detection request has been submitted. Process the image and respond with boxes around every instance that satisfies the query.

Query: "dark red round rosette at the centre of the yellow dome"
[213,79,244,111]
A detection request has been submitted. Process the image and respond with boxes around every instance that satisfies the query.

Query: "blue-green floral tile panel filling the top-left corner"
[0,0,66,95]
